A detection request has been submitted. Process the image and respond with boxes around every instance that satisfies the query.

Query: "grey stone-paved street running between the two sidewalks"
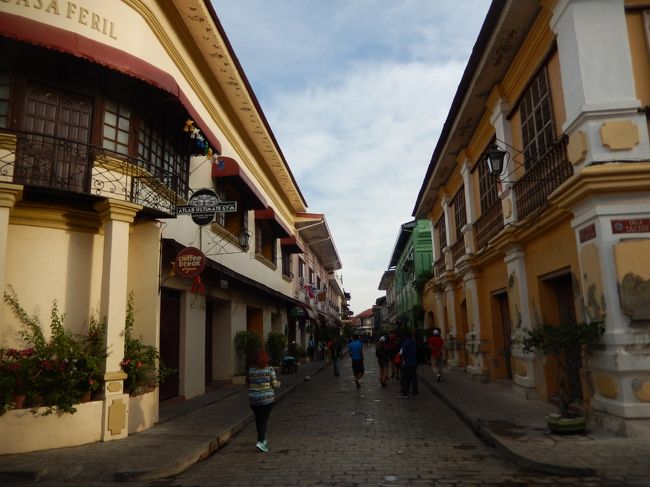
[159,349,625,487]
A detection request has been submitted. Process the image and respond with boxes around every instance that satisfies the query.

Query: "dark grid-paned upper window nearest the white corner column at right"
[520,67,555,170]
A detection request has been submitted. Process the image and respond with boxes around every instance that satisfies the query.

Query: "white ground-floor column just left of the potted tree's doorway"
[505,245,537,397]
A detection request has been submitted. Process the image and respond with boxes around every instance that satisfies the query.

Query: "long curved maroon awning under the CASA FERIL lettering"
[0,12,221,154]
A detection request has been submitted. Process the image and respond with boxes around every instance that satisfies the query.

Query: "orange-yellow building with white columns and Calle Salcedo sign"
[413,0,650,435]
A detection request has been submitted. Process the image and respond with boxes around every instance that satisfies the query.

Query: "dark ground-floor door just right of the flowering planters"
[160,288,181,400]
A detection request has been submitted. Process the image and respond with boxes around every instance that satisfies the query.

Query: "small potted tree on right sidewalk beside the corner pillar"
[522,322,605,434]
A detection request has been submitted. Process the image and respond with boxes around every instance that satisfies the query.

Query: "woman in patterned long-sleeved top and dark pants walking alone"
[248,350,280,452]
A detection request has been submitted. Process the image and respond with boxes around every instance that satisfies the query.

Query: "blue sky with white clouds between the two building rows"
[212,0,490,314]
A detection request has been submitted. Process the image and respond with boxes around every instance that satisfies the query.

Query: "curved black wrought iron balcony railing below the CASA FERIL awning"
[0,129,188,218]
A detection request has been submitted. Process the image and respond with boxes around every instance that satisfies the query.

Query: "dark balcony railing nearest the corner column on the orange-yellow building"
[513,137,573,220]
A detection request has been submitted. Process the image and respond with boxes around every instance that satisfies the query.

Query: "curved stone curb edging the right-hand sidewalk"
[418,374,596,477]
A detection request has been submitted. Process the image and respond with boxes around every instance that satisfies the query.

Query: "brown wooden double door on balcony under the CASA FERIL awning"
[16,84,92,192]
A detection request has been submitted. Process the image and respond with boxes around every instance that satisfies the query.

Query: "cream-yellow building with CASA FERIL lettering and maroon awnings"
[0,0,345,453]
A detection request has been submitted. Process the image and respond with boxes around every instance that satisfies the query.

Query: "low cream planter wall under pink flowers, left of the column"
[0,401,103,454]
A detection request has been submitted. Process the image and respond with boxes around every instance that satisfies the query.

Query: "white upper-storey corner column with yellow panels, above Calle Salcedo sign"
[550,0,650,172]
